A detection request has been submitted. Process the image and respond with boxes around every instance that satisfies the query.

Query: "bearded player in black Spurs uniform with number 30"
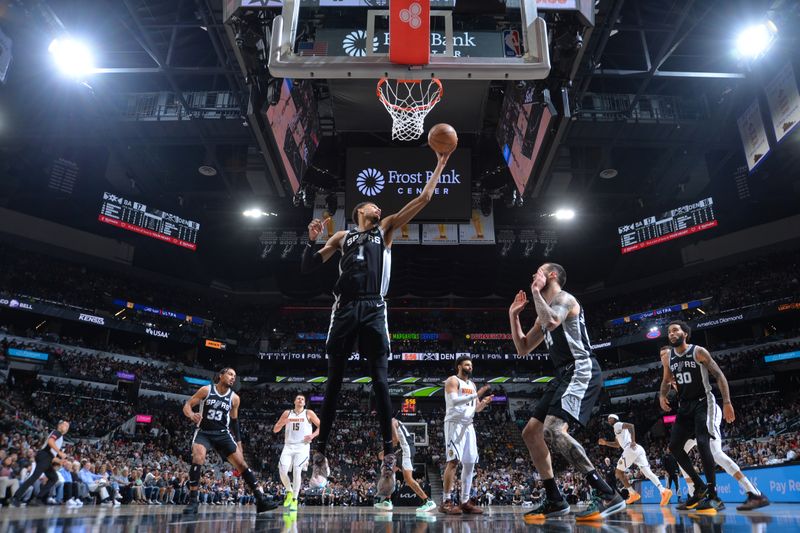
[659,320,736,514]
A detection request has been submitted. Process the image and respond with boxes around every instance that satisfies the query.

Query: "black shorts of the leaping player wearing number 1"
[325,297,391,359]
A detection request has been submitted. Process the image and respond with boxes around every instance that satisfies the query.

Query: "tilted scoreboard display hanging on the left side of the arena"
[98,192,200,251]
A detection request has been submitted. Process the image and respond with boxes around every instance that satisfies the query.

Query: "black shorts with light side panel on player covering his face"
[533,357,603,426]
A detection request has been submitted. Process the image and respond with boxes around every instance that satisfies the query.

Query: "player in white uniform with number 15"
[272,394,319,511]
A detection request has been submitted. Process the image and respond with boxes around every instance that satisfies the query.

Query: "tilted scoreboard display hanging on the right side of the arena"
[617,197,718,254]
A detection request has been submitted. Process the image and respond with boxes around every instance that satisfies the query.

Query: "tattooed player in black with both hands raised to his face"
[508,263,625,522]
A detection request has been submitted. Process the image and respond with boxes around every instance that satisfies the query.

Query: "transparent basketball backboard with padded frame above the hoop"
[231,0,550,80]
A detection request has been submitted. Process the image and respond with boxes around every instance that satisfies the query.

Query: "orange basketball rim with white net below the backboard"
[377,78,442,141]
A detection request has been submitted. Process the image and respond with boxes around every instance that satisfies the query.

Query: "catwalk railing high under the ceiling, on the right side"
[576,93,709,124]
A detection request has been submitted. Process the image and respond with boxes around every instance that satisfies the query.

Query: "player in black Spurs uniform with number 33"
[183,368,278,515]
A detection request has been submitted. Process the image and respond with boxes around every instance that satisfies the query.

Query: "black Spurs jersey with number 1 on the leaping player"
[333,226,392,298]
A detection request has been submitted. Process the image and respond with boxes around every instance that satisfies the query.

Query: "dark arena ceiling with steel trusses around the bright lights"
[0,0,800,297]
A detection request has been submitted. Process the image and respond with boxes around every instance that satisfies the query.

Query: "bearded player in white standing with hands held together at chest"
[439,355,494,514]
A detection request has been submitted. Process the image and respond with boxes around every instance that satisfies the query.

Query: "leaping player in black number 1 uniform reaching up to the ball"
[301,149,450,497]
